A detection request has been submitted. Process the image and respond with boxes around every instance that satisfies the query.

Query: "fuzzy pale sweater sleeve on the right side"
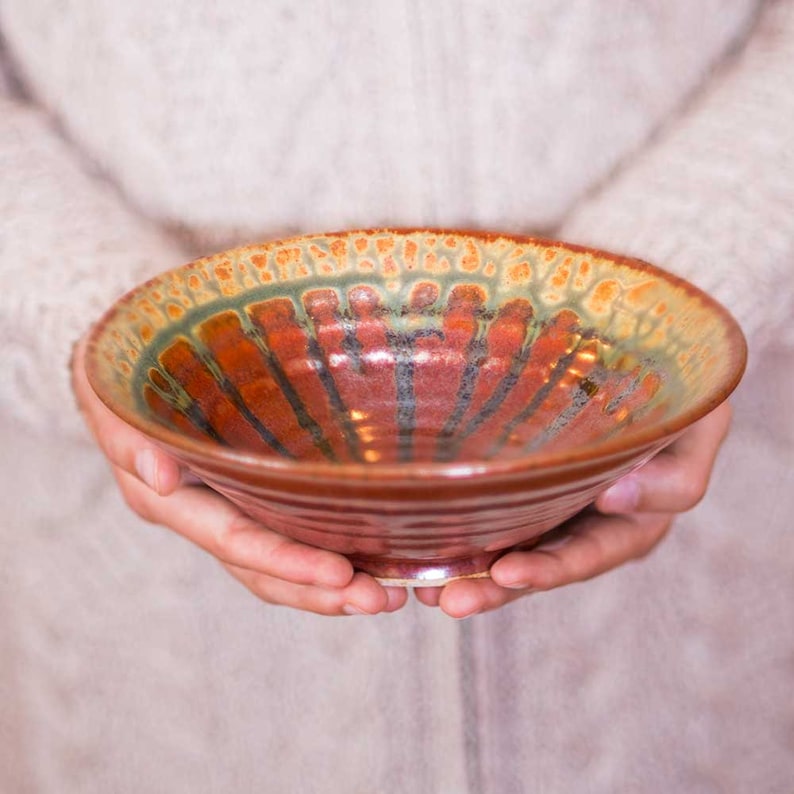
[559,0,794,354]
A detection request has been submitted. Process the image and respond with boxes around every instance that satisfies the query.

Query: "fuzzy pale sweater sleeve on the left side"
[0,92,186,435]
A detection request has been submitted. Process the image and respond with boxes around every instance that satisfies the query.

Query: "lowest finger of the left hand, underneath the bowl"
[225,564,405,615]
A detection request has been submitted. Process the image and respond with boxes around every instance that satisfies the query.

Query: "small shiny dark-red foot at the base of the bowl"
[350,552,503,587]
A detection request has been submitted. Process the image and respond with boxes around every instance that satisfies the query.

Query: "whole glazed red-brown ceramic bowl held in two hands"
[87,230,746,585]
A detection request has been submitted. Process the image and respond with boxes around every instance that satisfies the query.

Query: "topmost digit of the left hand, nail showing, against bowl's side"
[72,340,184,496]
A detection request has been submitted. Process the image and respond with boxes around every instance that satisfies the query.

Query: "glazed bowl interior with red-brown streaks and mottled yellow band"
[88,230,744,464]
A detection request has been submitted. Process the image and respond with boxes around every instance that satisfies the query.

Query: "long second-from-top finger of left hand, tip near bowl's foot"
[115,468,352,588]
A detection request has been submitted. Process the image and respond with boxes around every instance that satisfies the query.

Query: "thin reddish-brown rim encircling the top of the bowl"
[84,226,748,482]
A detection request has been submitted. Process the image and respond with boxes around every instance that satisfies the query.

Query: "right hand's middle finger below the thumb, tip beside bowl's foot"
[488,513,672,592]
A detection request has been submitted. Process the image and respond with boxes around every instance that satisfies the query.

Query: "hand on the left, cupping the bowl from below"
[72,332,406,615]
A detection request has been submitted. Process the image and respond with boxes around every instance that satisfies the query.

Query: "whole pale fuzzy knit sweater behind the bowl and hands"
[0,0,794,794]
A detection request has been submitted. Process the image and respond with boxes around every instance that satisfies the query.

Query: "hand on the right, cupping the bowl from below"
[416,403,731,618]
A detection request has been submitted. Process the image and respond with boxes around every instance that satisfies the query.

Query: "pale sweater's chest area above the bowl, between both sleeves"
[3,0,755,239]
